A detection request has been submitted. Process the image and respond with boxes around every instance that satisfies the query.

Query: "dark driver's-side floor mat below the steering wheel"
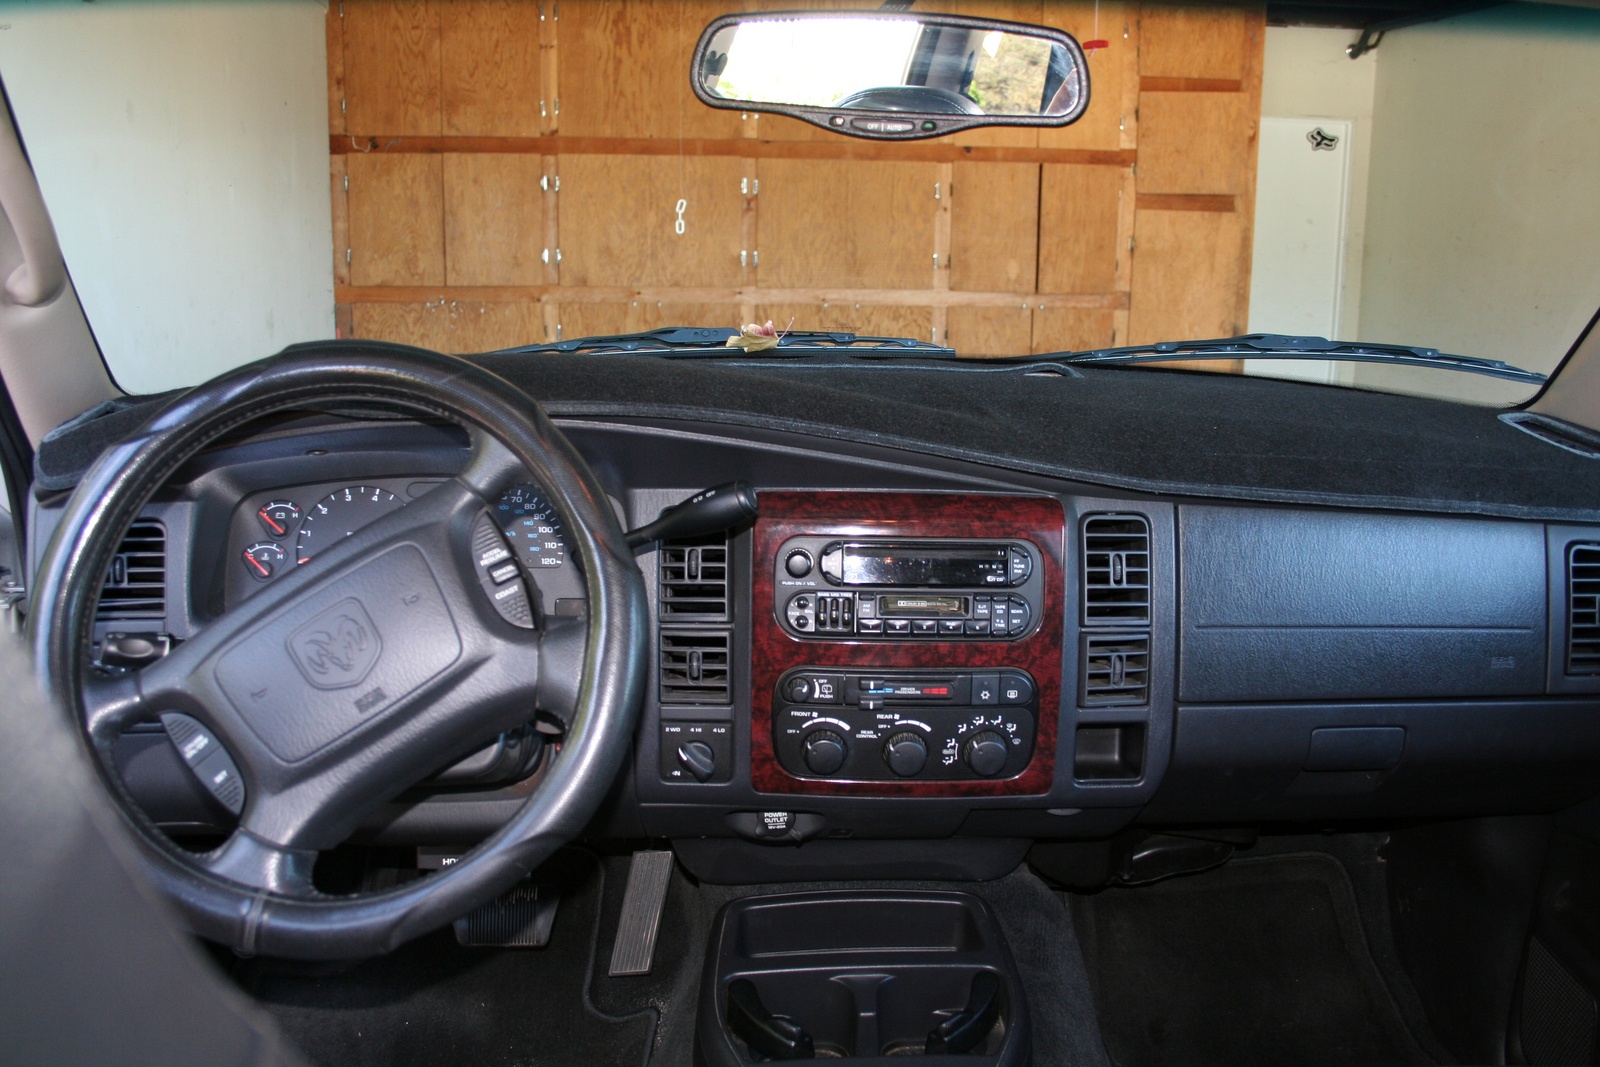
[235,851,656,1067]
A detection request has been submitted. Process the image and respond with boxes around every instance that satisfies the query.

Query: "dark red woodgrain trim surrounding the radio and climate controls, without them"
[750,491,1066,797]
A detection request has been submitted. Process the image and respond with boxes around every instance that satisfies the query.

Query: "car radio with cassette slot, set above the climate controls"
[773,536,1043,641]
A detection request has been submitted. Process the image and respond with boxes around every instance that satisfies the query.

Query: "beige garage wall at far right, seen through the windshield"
[1354,3,1600,403]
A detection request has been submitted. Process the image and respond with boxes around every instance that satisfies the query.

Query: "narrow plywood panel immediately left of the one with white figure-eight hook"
[443,155,546,285]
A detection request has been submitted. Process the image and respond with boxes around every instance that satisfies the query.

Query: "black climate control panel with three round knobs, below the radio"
[773,667,1038,781]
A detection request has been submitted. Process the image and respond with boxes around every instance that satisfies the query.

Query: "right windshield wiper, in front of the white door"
[1035,333,1546,386]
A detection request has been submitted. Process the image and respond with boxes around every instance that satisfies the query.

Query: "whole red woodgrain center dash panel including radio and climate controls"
[750,493,1064,797]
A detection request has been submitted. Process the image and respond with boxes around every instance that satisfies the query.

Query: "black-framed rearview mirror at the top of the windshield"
[690,11,1090,141]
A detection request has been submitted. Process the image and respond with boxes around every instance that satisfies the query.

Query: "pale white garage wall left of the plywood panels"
[0,0,333,392]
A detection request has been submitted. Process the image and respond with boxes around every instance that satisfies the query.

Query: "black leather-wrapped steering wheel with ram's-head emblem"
[29,341,646,960]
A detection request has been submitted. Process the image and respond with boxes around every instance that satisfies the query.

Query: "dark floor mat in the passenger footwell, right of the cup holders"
[1072,854,1434,1067]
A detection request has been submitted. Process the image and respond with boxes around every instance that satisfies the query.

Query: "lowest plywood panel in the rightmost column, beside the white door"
[1128,211,1250,344]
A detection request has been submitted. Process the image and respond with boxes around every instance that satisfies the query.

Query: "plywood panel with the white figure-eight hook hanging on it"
[557,155,742,286]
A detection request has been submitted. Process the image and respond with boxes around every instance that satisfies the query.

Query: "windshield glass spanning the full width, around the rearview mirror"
[0,0,1600,405]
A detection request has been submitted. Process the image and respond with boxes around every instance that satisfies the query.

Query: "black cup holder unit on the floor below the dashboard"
[696,891,1027,1067]
